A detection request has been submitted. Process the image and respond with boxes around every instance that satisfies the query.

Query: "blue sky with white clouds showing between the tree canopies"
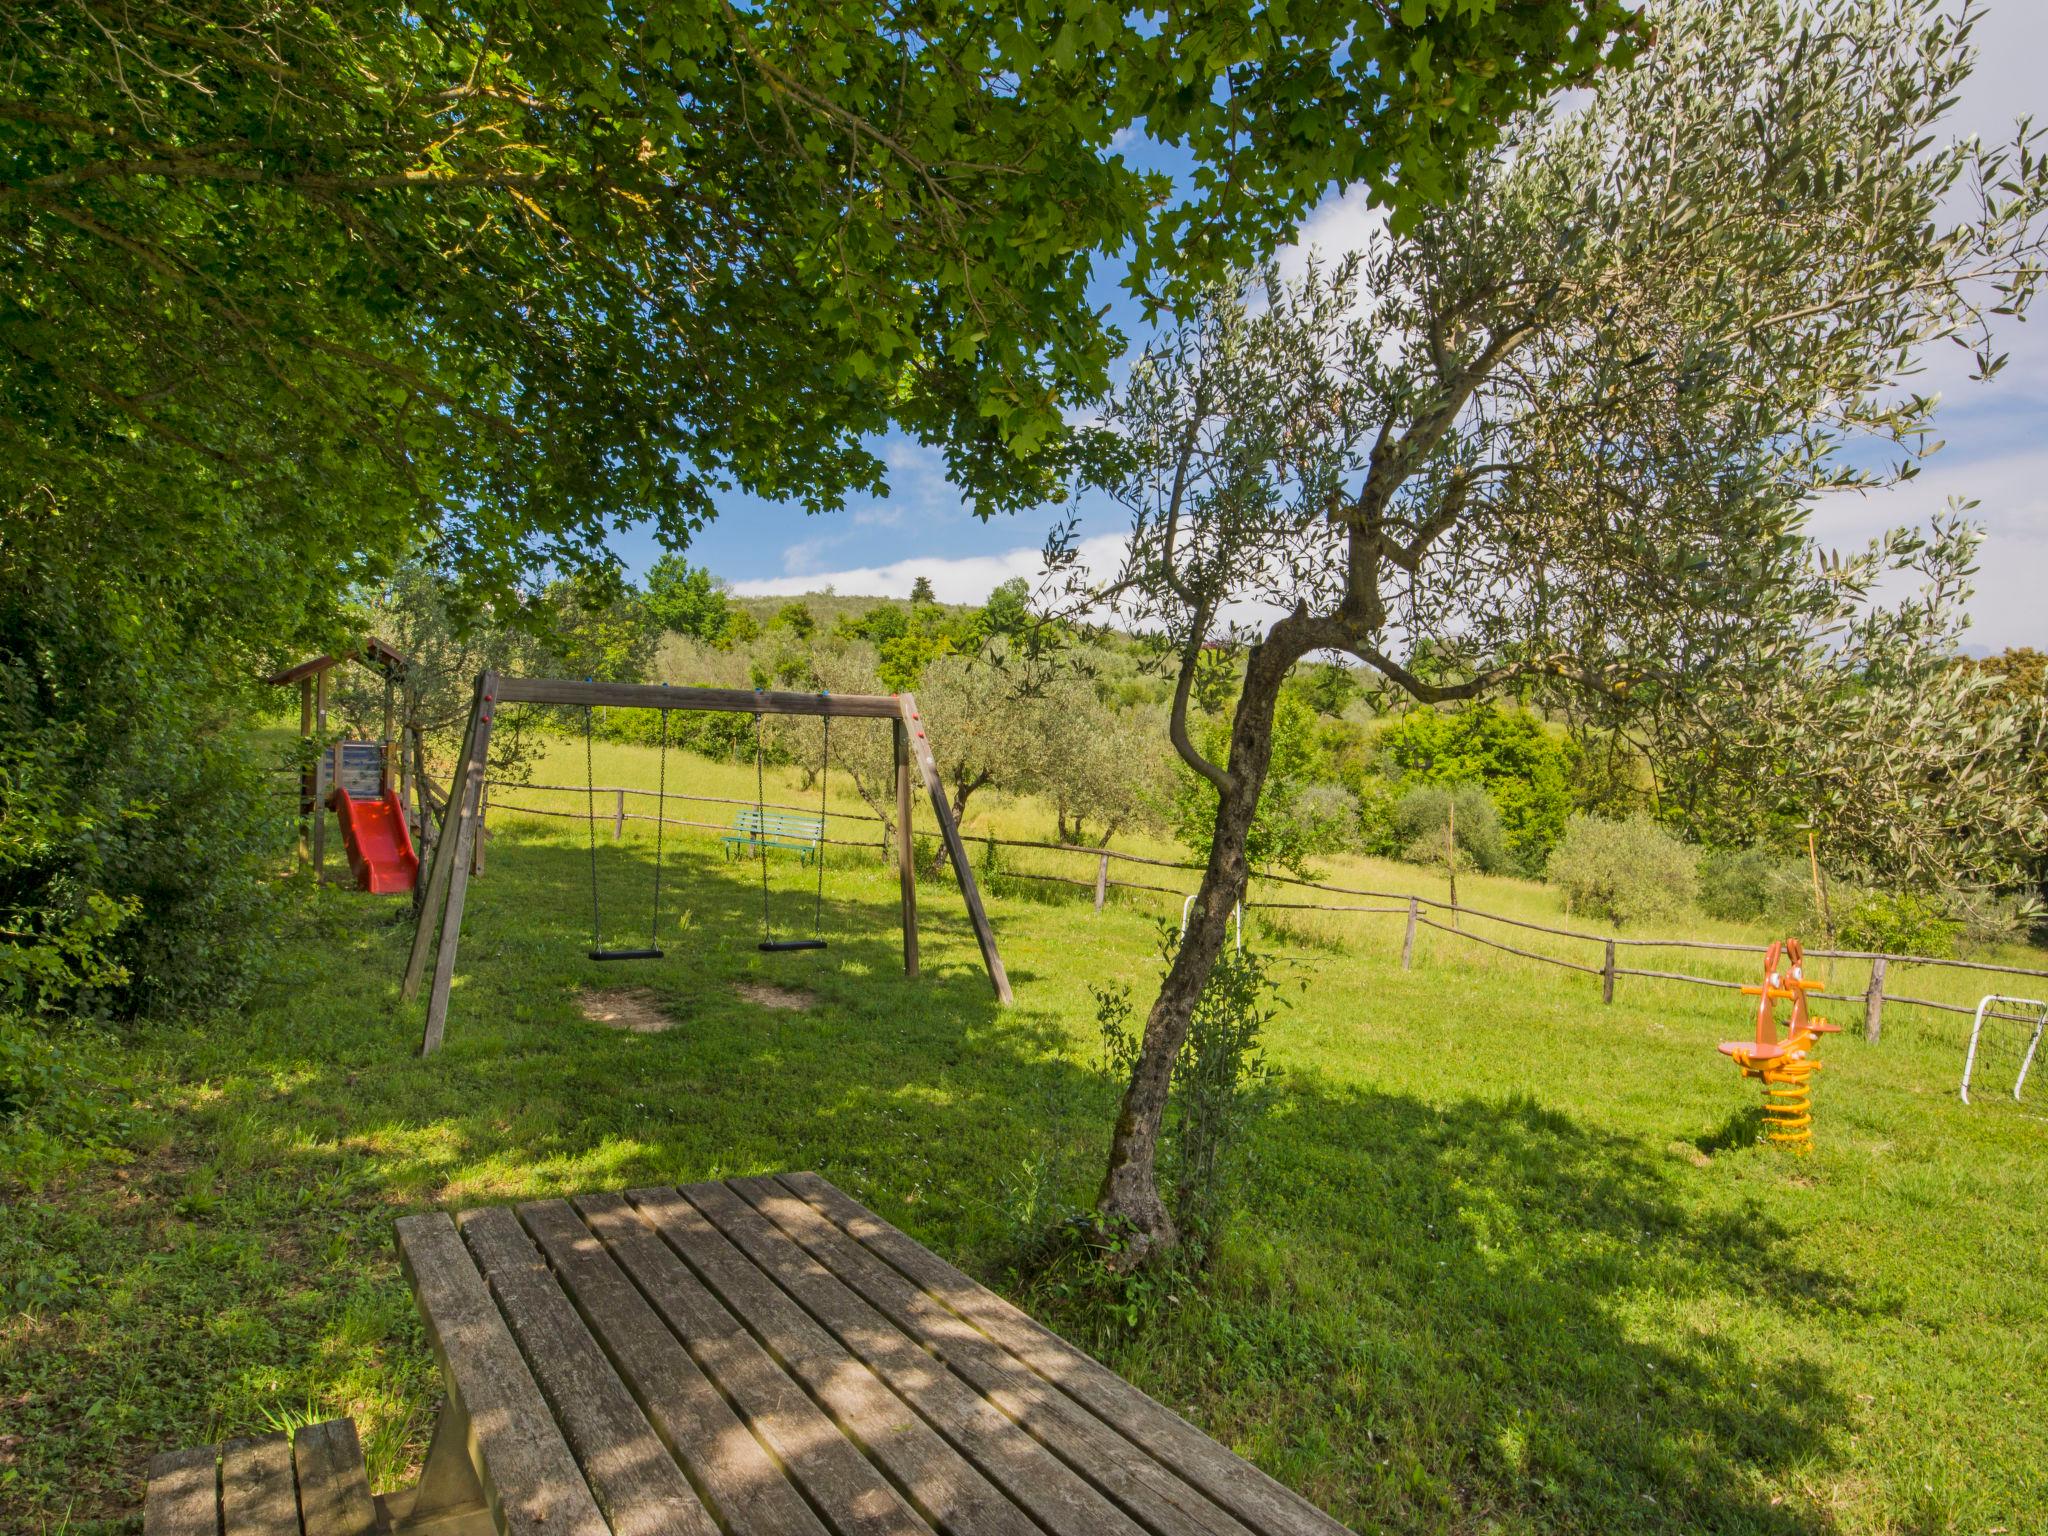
[618,0,2048,649]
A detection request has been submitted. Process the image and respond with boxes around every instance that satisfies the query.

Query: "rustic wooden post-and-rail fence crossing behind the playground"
[485,778,2048,1040]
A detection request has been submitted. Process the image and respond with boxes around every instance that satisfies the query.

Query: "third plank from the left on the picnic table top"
[518,1200,825,1536]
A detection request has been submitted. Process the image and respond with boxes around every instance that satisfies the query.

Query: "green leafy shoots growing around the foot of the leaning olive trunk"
[1094,928,1280,1270]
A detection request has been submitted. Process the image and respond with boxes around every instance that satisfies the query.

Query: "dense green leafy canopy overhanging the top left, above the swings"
[0,0,1622,638]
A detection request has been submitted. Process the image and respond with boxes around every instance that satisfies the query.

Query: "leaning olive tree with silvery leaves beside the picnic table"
[1053,0,2048,1257]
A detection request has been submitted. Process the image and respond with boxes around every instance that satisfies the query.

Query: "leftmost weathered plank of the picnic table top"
[395,1210,610,1536]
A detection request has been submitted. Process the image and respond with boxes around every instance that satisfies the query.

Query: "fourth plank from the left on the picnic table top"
[575,1194,932,1536]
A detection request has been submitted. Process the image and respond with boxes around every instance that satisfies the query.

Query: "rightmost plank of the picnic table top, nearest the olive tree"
[780,1174,1346,1536]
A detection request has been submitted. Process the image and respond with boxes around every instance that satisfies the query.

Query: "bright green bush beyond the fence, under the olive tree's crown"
[1376,702,1579,874]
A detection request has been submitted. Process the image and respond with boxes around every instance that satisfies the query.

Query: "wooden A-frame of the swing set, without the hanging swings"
[399,672,1014,1057]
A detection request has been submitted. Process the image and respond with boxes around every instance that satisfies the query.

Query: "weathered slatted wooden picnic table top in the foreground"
[397,1174,1343,1536]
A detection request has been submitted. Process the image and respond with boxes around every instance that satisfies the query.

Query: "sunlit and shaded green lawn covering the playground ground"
[0,743,2048,1534]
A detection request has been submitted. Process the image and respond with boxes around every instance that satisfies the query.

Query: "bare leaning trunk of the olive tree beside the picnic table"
[1096,618,1309,1268]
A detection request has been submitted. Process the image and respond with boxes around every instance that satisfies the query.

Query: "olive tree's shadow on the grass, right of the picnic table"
[1022,1081,1858,1536]
